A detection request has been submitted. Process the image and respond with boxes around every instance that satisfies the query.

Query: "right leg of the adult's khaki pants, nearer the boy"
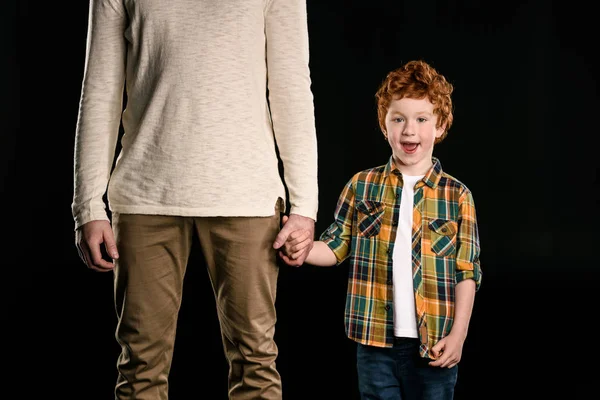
[195,209,281,400]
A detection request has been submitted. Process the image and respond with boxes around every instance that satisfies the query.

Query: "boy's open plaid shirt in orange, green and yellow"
[320,157,481,357]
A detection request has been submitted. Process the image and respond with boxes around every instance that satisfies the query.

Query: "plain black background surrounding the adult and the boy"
[0,0,598,400]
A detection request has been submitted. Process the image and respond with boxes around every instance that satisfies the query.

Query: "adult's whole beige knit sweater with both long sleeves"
[72,0,318,228]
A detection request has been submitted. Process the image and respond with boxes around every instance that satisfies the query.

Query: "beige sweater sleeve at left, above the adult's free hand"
[71,0,127,229]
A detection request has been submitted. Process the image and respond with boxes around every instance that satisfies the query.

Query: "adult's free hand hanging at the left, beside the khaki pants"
[75,220,119,272]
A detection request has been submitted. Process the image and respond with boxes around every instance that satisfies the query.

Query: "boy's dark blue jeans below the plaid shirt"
[356,338,458,400]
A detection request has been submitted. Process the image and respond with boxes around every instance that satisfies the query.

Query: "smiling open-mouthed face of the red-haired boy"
[385,98,444,175]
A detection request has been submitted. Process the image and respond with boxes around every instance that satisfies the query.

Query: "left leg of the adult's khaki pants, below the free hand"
[113,214,193,400]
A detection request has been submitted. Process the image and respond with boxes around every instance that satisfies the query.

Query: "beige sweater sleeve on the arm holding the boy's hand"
[265,0,318,220]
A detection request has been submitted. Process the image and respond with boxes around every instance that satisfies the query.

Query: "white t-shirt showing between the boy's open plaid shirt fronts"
[392,175,424,338]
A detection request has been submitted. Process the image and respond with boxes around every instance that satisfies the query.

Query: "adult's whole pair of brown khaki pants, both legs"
[113,208,281,400]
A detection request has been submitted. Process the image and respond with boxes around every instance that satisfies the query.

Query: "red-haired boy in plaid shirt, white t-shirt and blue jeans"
[280,61,481,400]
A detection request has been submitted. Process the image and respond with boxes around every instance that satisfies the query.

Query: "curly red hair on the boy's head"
[375,60,454,143]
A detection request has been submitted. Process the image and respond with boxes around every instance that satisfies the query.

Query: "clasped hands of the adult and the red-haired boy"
[273,214,315,266]
